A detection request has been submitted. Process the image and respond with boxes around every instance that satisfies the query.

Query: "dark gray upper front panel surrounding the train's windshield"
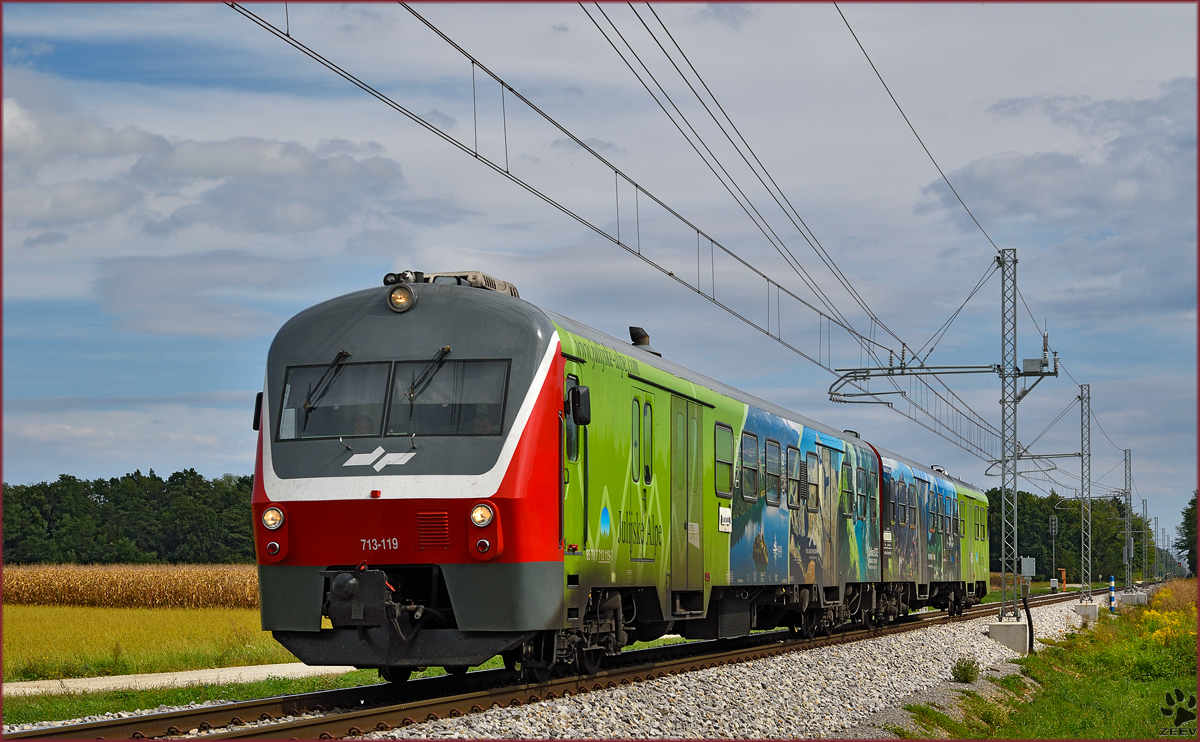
[263,283,554,479]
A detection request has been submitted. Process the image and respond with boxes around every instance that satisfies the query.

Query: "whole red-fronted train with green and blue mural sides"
[252,270,989,682]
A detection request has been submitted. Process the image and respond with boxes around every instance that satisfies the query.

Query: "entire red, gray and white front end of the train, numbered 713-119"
[253,268,564,680]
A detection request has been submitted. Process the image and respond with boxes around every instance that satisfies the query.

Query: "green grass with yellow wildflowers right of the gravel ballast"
[890,579,1196,740]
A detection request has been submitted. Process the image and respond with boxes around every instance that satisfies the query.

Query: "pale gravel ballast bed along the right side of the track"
[367,602,1079,740]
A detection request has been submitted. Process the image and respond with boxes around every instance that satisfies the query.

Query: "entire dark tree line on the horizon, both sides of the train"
[4,469,1196,573]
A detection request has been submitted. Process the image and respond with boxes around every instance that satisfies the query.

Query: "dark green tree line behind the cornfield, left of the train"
[4,469,254,564]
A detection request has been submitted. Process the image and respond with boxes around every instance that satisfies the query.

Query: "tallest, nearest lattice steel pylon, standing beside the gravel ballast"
[996,247,1020,621]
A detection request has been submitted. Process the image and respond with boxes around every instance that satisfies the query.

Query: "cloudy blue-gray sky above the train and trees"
[2,2,1196,538]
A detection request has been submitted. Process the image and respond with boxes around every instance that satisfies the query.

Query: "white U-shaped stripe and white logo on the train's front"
[262,331,559,502]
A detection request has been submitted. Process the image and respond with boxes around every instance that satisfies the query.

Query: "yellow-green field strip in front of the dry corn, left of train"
[4,604,295,682]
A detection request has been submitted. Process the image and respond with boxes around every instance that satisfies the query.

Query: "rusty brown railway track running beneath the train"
[5,585,1078,740]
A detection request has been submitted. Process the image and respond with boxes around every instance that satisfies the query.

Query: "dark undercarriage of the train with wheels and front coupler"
[275,566,986,682]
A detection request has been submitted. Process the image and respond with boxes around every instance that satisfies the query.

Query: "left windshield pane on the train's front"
[278,363,390,441]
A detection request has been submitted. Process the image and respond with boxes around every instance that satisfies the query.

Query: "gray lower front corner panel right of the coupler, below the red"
[440,562,565,632]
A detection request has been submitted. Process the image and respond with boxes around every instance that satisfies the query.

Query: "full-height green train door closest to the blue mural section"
[671,396,704,615]
